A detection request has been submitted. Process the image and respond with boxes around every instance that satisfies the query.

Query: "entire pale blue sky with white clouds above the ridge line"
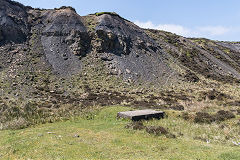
[17,0,240,41]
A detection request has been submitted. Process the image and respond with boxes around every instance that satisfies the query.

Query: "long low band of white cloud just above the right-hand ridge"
[134,21,232,38]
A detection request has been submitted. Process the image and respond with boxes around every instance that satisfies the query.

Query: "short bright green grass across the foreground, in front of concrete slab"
[0,106,240,159]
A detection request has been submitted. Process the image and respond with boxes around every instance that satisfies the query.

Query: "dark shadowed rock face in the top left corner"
[0,0,29,45]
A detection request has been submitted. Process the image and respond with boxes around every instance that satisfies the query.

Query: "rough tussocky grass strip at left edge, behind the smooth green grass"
[0,101,86,130]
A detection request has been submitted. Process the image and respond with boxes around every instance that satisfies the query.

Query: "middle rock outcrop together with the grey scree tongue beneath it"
[27,8,90,75]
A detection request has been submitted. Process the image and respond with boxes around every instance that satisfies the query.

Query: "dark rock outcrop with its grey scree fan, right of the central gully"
[96,14,173,81]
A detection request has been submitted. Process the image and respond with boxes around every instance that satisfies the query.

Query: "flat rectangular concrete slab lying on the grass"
[117,109,165,121]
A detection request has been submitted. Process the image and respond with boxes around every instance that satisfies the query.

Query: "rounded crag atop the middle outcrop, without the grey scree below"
[42,8,90,55]
